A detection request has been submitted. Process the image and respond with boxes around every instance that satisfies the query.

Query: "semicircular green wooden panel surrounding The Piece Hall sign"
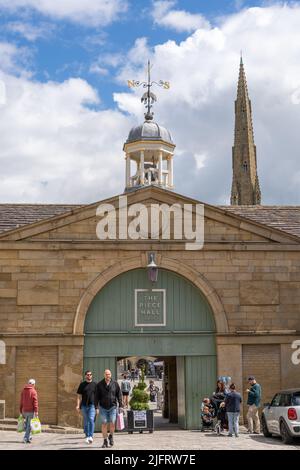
[85,269,215,333]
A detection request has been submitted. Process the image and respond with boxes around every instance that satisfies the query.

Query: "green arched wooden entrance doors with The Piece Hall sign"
[84,269,217,429]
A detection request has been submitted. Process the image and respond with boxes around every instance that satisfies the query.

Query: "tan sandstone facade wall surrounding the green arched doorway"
[0,187,300,425]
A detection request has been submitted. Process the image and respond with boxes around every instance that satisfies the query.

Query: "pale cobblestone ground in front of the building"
[0,429,300,452]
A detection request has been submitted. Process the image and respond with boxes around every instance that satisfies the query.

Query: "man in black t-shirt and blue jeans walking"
[76,370,99,444]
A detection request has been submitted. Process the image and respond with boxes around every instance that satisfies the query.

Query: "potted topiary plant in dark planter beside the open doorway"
[127,367,154,434]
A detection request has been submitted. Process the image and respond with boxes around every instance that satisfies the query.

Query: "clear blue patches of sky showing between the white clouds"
[0,0,265,108]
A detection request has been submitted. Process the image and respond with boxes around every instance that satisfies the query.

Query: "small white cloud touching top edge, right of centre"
[152,0,209,32]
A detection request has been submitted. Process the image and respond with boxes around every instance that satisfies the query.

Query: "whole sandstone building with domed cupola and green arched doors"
[0,60,300,428]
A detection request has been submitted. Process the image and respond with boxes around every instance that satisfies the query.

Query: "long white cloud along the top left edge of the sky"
[0,0,128,26]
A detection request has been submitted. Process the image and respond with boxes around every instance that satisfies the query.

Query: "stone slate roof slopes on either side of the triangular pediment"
[0,204,300,238]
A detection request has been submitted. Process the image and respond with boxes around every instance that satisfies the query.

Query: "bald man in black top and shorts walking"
[97,369,123,447]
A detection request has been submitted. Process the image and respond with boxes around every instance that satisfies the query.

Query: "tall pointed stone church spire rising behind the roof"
[230,55,261,205]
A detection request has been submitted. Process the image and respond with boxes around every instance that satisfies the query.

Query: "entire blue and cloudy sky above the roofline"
[0,0,300,204]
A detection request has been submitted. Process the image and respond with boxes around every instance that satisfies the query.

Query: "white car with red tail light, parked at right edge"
[262,388,300,444]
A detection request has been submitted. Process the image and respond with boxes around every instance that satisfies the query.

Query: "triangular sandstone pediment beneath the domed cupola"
[0,187,300,244]
